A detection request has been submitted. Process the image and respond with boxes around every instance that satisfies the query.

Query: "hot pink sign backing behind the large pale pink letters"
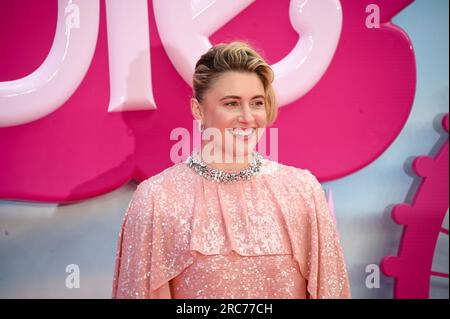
[0,0,416,202]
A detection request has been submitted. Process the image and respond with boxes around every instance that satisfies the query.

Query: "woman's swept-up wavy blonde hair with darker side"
[193,41,278,125]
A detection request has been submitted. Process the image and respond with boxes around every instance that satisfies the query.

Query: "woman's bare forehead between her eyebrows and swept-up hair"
[209,71,264,99]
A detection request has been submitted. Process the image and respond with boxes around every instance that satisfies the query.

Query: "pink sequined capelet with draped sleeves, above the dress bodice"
[113,159,350,298]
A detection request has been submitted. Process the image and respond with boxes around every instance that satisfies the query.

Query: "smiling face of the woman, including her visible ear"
[191,71,267,161]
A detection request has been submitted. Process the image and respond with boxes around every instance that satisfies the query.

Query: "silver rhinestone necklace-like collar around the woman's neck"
[186,151,263,183]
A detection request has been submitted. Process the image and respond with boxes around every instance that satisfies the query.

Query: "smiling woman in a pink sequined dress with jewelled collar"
[113,42,350,298]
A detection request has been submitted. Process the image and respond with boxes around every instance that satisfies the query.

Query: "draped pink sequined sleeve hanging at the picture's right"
[304,171,351,299]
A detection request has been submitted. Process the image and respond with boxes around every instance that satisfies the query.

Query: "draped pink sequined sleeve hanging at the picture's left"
[112,181,171,299]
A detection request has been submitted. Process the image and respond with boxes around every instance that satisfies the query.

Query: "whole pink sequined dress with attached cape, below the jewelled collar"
[112,158,351,299]
